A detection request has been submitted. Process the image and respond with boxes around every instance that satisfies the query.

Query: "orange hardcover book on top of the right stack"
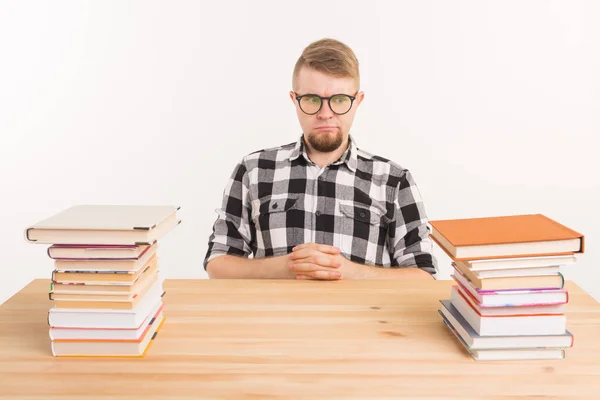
[430,214,584,260]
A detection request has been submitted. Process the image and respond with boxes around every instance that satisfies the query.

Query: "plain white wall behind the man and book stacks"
[0,0,600,302]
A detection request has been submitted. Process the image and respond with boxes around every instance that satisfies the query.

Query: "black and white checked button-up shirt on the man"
[204,136,436,273]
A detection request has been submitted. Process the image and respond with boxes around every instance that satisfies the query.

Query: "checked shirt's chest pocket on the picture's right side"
[339,203,390,265]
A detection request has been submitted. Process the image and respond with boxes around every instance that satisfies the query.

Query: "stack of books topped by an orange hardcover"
[431,214,584,360]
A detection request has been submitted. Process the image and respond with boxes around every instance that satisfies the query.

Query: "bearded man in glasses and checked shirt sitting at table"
[204,39,435,280]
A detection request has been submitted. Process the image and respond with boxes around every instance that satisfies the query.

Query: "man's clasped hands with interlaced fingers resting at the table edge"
[288,243,361,280]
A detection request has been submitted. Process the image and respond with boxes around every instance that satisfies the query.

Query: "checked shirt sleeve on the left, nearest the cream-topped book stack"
[204,160,252,270]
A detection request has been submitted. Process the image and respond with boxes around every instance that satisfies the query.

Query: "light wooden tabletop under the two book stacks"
[0,280,600,400]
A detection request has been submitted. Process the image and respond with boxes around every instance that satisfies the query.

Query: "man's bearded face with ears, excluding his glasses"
[290,67,364,153]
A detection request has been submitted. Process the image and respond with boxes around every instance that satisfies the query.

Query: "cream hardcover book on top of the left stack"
[25,205,181,245]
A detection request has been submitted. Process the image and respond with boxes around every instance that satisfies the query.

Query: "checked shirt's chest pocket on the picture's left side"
[253,197,304,256]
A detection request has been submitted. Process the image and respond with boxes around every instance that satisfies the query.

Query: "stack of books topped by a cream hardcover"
[25,205,181,356]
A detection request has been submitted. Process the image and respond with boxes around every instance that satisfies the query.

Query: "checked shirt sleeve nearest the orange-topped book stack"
[388,170,437,274]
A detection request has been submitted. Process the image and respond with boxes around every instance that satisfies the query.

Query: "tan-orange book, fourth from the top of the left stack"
[52,254,158,285]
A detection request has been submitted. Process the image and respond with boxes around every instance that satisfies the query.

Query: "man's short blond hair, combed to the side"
[292,38,360,90]
